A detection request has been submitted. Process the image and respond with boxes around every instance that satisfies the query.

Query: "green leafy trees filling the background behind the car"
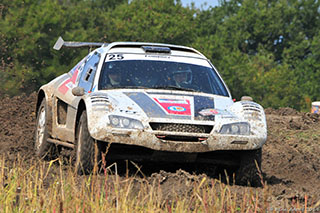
[0,0,320,110]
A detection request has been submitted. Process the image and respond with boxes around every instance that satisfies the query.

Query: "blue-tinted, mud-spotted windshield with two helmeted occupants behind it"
[99,60,228,96]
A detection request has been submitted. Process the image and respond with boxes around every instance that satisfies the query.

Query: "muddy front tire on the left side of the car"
[74,111,101,175]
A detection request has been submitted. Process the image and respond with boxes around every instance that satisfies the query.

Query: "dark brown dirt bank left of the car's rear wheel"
[0,93,36,163]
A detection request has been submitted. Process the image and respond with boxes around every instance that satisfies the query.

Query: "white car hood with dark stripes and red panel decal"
[92,89,233,121]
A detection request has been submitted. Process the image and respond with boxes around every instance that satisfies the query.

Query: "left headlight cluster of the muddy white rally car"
[109,115,143,129]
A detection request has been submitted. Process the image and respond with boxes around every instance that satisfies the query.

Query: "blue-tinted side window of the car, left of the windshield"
[78,52,100,92]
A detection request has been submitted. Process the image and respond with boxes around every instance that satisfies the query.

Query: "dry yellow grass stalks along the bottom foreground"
[0,157,319,212]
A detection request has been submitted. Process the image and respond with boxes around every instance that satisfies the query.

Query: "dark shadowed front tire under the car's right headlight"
[236,148,262,187]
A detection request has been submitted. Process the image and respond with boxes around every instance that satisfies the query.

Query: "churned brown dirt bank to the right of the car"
[262,112,320,199]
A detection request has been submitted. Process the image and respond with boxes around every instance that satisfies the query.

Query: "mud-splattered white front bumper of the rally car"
[91,128,267,153]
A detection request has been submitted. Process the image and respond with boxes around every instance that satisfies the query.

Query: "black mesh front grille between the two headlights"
[149,122,213,134]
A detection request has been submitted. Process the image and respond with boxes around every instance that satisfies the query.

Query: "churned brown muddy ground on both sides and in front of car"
[0,93,320,206]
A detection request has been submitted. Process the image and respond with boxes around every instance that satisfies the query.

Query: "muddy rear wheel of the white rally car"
[34,99,56,159]
